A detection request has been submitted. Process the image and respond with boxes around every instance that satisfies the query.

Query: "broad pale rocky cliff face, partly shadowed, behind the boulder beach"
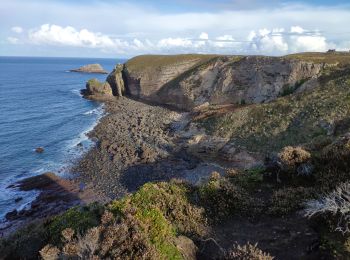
[124,56,324,110]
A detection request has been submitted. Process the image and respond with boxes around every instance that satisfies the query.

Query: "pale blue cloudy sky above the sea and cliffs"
[0,0,350,58]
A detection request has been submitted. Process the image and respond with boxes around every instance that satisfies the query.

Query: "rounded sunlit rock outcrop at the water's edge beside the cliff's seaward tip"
[81,79,113,100]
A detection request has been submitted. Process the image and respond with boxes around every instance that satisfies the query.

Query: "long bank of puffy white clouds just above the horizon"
[8,24,340,55]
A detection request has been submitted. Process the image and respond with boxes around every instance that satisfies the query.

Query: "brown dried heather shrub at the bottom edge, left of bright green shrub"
[40,211,159,259]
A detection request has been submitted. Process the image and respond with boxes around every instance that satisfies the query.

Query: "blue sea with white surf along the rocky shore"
[0,57,125,221]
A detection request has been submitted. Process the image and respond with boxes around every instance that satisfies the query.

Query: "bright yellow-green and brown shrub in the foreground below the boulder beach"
[109,181,206,259]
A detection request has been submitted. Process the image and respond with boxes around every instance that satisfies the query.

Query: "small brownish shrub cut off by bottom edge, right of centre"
[224,242,273,260]
